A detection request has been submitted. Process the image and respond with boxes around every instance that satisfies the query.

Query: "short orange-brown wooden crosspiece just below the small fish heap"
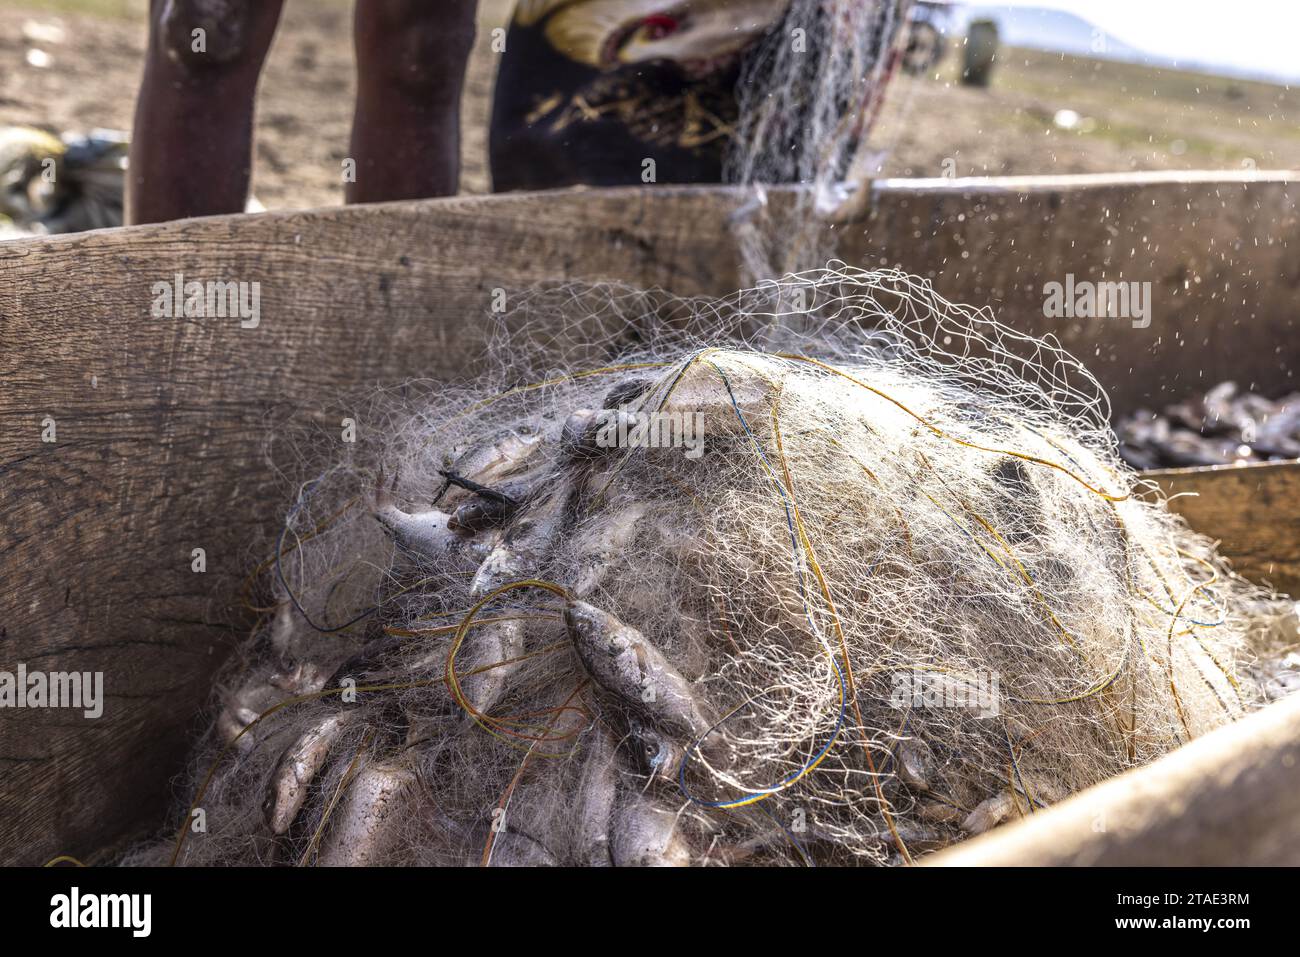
[1147,462,1300,596]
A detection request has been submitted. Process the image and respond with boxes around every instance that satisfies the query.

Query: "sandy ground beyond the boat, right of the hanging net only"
[874,47,1300,177]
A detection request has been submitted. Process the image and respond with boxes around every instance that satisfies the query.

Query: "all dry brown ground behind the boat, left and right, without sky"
[0,0,1300,208]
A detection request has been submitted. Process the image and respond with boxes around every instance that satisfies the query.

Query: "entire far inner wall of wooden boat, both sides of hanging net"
[0,174,1300,863]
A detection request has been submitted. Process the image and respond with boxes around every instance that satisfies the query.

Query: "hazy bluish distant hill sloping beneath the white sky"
[952,4,1296,83]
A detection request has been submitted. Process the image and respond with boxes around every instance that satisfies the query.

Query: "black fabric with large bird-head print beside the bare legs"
[491,0,789,190]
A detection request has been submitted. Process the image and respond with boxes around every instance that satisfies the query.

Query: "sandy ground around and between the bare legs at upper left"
[0,0,510,208]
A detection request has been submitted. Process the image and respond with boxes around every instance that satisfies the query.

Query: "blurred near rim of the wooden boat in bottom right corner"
[926,696,1300,867]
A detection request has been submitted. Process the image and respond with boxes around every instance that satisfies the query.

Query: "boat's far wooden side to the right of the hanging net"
[845,172,1300,412]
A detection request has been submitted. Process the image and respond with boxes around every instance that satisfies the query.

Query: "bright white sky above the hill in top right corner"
[946,0,1300,81]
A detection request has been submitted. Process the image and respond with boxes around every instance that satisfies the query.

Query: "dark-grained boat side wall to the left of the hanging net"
[0,192,735,863]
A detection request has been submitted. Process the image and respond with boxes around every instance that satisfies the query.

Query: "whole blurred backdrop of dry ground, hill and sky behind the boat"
[0,0,1300,208]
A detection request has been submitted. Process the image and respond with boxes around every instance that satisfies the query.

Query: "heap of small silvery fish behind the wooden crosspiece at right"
[1115,382,1300,468]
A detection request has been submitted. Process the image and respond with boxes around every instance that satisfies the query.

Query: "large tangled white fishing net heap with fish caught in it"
[144,265,1258,865]
